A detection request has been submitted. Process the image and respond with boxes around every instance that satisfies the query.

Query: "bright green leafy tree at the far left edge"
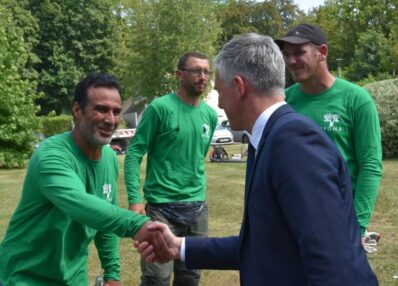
[0,4,39,168]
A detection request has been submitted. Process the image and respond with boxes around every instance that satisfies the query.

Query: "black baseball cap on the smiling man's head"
[275,24,328,49]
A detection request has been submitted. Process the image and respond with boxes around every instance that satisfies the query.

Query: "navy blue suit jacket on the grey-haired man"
[186,105,378,286]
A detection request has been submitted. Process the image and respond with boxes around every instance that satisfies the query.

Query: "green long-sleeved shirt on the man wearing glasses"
[124,93,217,204]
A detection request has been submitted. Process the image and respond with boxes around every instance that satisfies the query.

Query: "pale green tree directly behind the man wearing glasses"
[122,0,220,99]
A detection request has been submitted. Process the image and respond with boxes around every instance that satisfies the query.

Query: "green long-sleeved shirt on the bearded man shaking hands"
[0,132,148,286]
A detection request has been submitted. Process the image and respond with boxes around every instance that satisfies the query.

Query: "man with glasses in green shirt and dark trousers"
[124,52,217,286]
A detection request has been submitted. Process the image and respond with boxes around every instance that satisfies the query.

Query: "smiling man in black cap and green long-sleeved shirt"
[275,24,382,252]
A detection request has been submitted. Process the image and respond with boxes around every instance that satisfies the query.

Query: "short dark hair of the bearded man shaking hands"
[73,72,122,109]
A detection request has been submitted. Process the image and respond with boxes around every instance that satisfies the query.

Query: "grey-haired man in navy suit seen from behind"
[136,34,378,286]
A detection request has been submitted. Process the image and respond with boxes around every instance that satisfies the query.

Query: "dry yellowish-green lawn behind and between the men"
[0,145,398,286]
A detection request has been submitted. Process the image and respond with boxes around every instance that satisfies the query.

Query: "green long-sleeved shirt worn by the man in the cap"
[285,78,382,234]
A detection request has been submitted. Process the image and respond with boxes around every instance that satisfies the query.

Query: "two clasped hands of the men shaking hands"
[133,221,183,263]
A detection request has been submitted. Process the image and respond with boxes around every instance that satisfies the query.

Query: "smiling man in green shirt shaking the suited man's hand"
[0,73,169,286]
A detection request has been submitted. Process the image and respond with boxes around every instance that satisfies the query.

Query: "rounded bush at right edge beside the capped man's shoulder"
[364,79,398,158]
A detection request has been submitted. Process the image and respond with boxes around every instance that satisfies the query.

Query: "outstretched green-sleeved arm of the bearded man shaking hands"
[39,158,148,237]
